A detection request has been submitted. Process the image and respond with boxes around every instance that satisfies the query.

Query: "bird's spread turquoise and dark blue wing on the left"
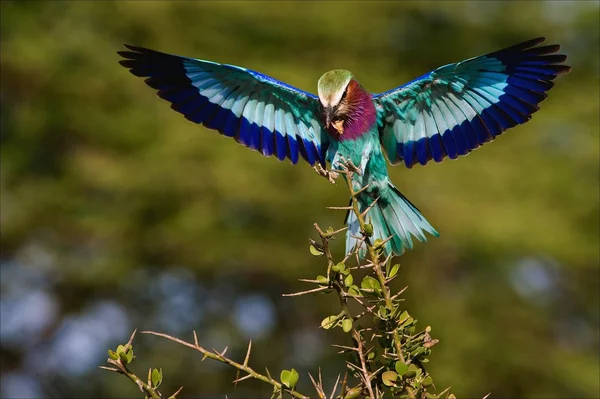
[118,45,328,165]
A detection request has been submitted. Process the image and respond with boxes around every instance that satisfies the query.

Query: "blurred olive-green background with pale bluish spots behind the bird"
[0,1,600,398]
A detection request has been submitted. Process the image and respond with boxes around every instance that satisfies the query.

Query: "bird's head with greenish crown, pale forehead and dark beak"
[318,69,352,134]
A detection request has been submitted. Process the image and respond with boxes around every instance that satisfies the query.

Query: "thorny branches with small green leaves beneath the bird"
[102,162,462,399]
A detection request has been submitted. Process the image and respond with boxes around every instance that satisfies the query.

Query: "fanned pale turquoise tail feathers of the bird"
[346,183,439,258]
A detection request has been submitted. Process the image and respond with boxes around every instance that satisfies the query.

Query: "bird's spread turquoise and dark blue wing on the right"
[373,38,571,168]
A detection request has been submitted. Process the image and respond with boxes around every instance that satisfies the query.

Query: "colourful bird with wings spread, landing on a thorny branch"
[118,37,571,257]
